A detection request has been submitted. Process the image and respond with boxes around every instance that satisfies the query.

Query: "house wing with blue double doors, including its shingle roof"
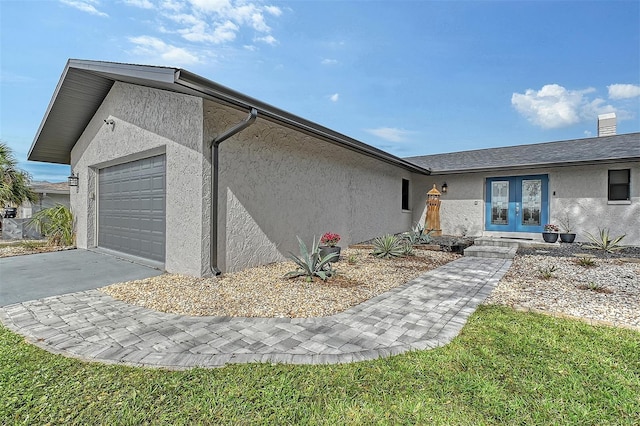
[406,127,640,245]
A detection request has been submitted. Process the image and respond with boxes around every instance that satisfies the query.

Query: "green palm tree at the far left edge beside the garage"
[0,142,38,207]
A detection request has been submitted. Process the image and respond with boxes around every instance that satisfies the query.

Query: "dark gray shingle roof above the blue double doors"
[405,133,640,174]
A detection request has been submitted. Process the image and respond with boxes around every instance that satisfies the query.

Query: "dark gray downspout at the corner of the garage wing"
[209,108,258,276]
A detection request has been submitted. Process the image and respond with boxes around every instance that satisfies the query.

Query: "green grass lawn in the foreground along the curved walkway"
[0,306,640,425]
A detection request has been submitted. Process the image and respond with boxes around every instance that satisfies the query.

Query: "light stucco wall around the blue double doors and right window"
[416,162,640,246]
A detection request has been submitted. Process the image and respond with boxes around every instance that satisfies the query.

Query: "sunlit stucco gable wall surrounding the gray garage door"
[71,83,207,276]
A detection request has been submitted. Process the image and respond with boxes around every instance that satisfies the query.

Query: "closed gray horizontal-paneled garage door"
[98,155,166,262]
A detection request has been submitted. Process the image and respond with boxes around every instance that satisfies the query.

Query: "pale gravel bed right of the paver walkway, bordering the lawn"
[485,244,640,330]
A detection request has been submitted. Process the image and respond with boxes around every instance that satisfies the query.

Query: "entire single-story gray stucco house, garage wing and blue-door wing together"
[28,60,640,276]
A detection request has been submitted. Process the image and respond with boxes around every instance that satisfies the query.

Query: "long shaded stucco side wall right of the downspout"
[205,101,413,271]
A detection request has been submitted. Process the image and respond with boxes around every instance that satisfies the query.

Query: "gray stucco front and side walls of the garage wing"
[71,83,416,276]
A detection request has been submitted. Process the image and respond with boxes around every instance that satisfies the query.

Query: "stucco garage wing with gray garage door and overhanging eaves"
[28,60,429,276]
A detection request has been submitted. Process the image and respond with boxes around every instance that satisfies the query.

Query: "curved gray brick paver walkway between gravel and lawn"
[0,257,511,369]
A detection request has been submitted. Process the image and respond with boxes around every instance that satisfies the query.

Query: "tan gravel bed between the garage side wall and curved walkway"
[100,248,460,318]
